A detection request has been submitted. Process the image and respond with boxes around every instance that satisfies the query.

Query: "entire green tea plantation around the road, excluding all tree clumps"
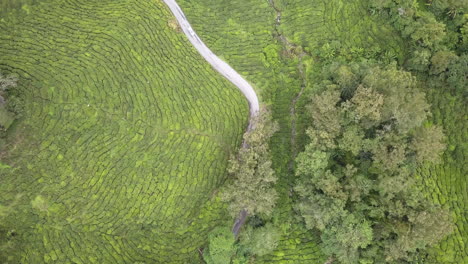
[0,0,468,264]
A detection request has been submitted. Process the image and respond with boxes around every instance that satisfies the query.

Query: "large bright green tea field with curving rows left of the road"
[0,0,248,263]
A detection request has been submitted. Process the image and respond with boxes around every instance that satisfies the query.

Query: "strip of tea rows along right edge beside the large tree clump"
[420,90,468,263]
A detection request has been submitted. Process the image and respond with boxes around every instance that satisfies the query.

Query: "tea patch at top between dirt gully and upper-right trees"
[274,0,404,58]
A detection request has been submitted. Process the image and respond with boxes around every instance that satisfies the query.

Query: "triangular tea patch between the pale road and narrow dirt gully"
[177,0,277,98]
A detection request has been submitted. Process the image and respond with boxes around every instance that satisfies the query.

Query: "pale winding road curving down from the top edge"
[163,0,260,118]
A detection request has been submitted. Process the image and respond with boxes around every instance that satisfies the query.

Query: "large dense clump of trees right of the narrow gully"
[295,60,451,263]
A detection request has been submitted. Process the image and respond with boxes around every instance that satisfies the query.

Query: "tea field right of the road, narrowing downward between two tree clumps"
[179,0,401,263]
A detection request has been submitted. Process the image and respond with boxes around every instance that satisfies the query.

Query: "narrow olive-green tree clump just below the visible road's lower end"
[222,108,278,217]
